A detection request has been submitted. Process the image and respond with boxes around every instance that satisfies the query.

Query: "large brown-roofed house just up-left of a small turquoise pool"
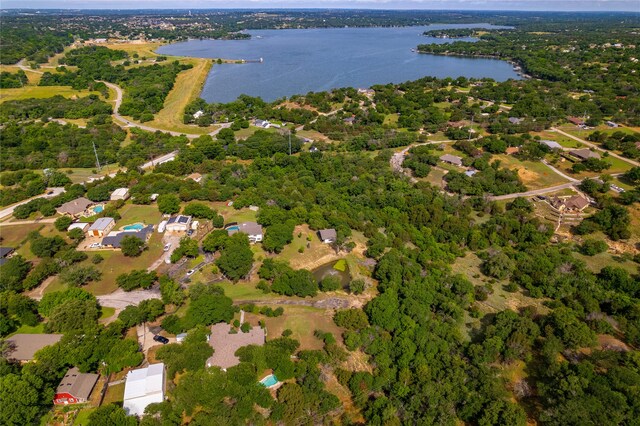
[207,322,265,371]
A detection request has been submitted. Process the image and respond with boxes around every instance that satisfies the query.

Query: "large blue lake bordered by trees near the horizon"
[157,24,519,102]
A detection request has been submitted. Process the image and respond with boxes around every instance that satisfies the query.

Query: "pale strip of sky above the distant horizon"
[5,0,640,12]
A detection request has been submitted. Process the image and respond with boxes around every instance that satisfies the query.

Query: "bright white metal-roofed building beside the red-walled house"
[122,363,164,416]
